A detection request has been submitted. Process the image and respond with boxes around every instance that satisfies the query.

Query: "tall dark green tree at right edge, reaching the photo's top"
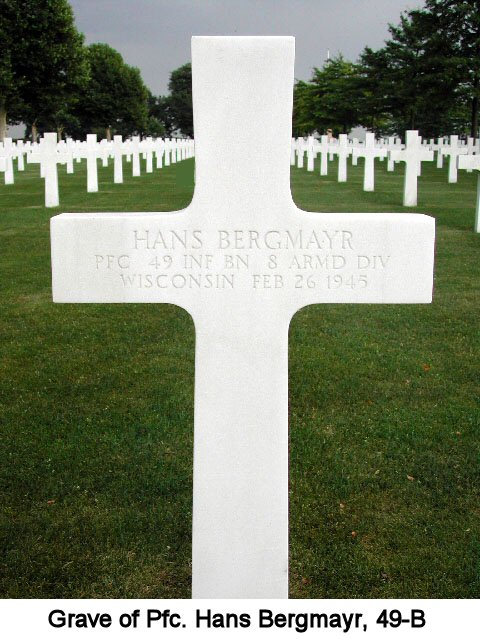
[360,0,474,137]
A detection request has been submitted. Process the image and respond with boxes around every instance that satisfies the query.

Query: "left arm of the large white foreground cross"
[50,210,204,309]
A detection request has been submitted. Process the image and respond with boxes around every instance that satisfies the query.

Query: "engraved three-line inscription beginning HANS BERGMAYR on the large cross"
[92,227,392,291]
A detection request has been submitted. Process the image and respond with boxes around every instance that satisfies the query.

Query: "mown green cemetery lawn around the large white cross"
[0,160,480,598]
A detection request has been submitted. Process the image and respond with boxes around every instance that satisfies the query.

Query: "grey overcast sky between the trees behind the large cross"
[70,0,423,95]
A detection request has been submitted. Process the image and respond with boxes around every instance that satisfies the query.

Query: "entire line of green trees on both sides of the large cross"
[0,0,480,140]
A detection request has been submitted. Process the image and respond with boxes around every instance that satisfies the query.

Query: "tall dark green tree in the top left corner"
[0,0,88,137]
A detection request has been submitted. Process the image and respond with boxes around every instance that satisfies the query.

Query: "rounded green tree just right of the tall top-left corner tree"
[77,43,148,139]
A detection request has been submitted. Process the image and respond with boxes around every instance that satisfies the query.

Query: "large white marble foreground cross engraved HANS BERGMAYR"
[51,37,435,598]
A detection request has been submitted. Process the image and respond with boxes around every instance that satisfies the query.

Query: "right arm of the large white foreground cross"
[284,211,435,312]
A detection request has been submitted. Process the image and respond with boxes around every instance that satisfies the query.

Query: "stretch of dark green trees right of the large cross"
[293,0,480,137]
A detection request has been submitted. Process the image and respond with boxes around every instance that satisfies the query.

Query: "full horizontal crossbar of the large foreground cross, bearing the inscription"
[51,205,435,315]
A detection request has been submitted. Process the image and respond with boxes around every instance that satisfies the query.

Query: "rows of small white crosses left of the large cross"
[0,133,194,207]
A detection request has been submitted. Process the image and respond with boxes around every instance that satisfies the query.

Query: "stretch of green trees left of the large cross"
[0,0,193,140]
